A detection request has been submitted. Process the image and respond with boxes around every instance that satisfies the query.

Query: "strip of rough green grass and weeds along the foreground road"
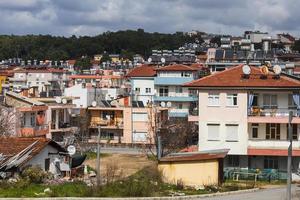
[0,167,258,197]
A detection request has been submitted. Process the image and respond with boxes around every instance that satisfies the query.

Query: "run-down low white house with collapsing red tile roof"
[0,137,71,178]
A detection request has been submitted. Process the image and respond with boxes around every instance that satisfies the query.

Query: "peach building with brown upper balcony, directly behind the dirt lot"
[88,97,167,144]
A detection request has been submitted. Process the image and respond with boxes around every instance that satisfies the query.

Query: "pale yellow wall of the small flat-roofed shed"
[158,160,219,187]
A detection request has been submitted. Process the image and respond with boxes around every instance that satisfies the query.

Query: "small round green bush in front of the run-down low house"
[21,166,49,184]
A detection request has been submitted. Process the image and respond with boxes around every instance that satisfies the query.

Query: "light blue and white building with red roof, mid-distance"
[154,64,200,117]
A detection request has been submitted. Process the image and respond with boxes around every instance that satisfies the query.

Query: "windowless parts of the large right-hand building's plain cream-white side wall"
[199,90,248,155]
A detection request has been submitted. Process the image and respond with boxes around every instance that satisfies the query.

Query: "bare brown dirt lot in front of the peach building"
[84,154,156,176]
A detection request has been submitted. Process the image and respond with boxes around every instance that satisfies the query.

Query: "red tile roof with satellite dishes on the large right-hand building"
[184,65,300,88]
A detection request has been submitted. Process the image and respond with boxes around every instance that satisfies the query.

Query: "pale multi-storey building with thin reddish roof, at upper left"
[9,68,70,97]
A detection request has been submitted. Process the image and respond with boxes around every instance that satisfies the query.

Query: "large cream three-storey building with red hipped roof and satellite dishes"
[185,66,300,173]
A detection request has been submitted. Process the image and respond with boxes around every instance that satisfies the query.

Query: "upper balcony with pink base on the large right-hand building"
[248,106,300,123]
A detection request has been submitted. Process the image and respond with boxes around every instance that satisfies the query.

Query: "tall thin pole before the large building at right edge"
[286,111,293,200]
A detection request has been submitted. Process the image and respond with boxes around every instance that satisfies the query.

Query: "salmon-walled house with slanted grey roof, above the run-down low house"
[5,92,49,137]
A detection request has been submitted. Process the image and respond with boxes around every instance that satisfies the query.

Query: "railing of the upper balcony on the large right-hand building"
[249,106,299,117]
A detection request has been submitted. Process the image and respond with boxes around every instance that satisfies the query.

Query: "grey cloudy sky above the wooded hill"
[0,0,300,36]
